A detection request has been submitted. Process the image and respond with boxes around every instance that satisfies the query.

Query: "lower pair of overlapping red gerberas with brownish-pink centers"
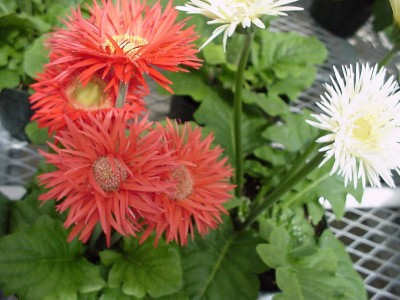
[39,109,233,245]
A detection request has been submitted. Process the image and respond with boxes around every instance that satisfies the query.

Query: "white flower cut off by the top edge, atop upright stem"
[176,0,303,51]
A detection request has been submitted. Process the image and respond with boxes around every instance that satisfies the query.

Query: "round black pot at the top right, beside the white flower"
[310,0,374,38]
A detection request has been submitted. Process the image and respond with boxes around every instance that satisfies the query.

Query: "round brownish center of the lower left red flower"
[93,156,128,193]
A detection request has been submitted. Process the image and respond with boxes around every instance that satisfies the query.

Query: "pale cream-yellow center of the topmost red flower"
[104,34,149,58]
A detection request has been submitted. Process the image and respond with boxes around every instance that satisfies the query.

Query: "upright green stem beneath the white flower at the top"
[233,32,254,197]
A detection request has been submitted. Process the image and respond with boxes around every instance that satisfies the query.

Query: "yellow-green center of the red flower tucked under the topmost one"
[66,77,113,110]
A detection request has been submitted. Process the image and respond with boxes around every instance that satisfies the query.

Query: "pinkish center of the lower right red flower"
[168,165,193,200]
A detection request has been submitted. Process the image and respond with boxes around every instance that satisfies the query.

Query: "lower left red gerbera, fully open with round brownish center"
[39,110,173,245]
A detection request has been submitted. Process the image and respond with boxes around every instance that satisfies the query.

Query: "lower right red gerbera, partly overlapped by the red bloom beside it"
[142,120,234,245]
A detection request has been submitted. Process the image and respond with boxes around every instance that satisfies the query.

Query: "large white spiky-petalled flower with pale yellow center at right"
[307,64,400,187]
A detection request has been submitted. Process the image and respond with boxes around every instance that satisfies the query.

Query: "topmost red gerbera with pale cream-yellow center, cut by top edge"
[48,0,200,91]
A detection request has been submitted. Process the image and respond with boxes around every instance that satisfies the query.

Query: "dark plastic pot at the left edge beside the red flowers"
[0,89,33,141]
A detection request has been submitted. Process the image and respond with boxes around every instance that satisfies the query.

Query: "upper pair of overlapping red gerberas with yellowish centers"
[31,0,201,133]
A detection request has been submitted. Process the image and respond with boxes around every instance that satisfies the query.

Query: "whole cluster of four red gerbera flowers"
[31,0,233,245]
